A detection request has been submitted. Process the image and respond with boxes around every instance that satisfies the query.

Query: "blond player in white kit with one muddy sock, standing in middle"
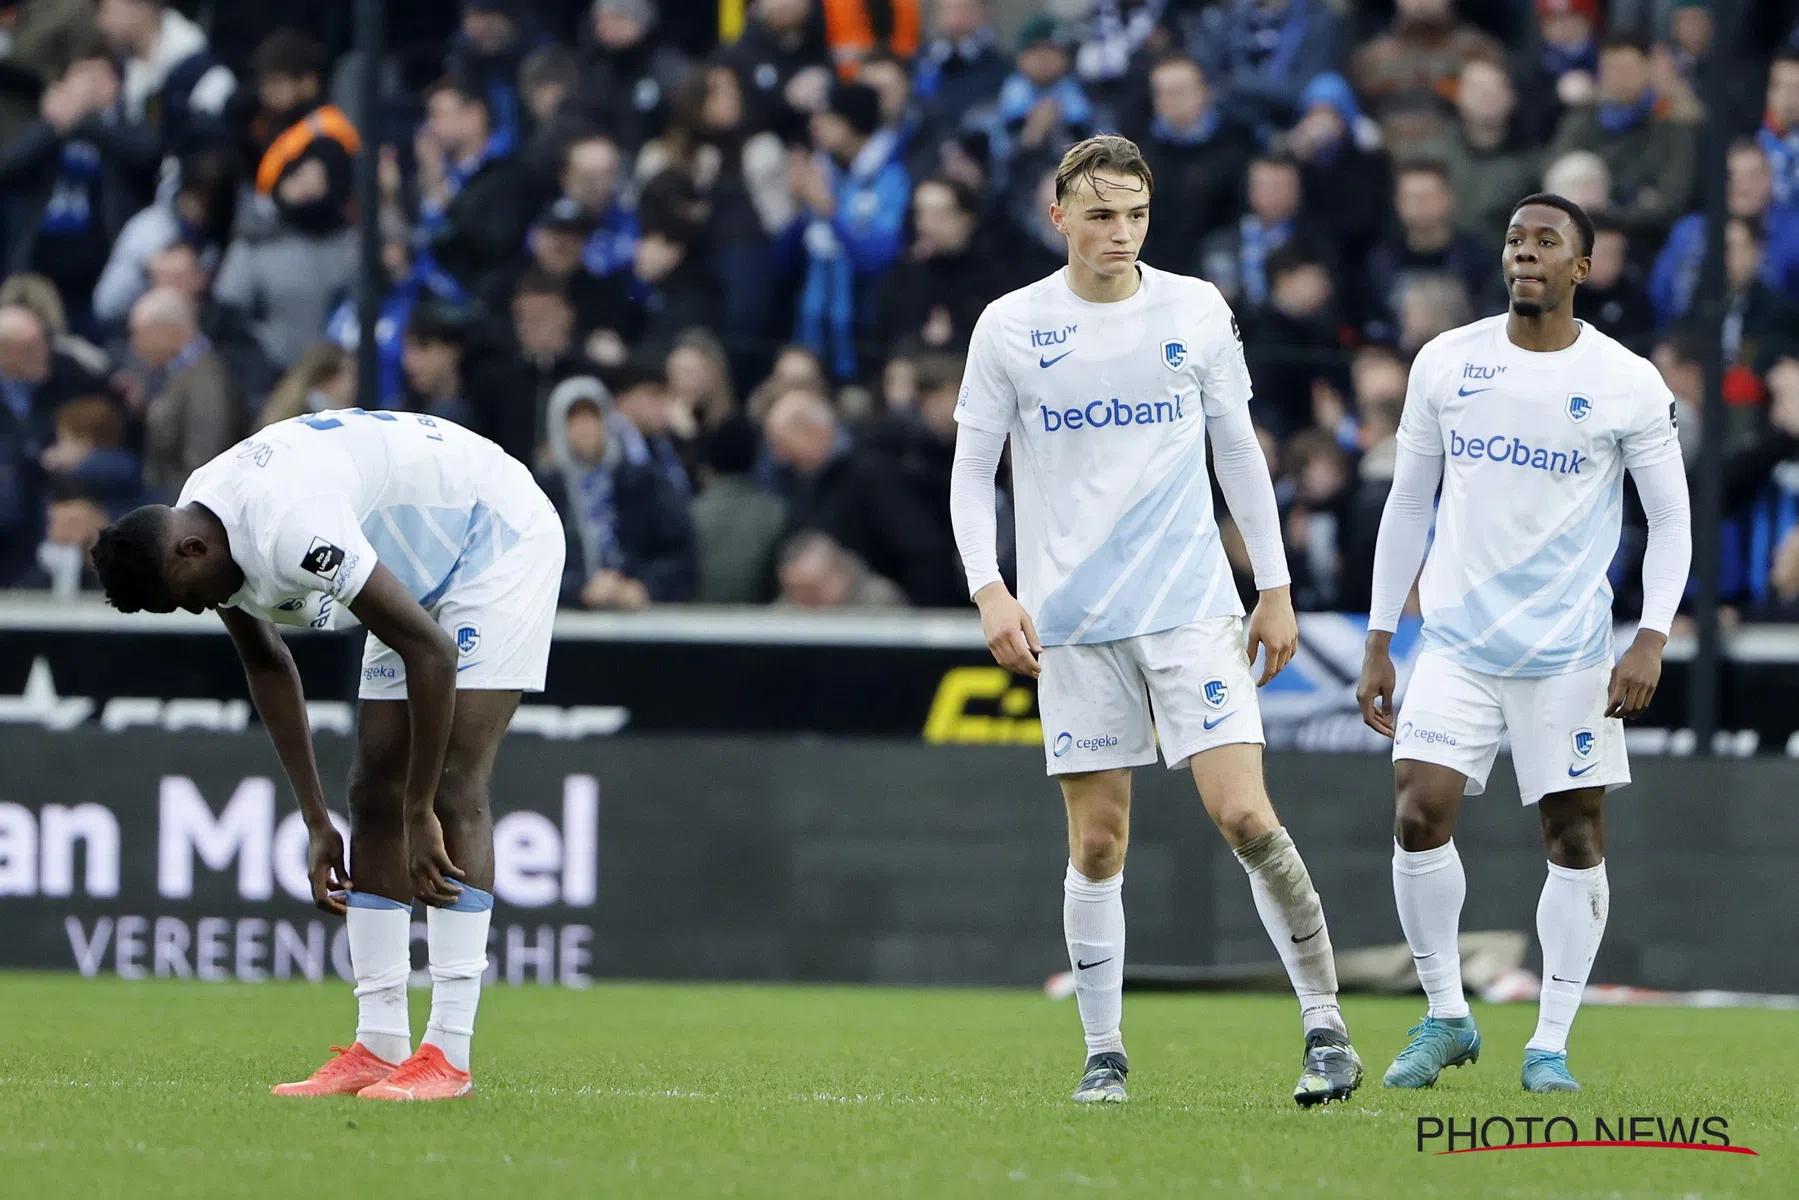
[950,137,1362,1105]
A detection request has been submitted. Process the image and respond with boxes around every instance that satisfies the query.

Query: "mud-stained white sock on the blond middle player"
[1236,828,1349,1036]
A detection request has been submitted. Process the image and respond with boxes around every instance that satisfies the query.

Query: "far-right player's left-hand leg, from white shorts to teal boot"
[1382,653,1504,1087]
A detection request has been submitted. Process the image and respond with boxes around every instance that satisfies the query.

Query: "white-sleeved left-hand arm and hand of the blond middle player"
[950,306,1043,678]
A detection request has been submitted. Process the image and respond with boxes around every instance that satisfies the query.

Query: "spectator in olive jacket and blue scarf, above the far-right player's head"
[1545,38,1698,237]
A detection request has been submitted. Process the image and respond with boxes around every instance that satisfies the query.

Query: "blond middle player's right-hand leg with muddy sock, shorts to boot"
[1133,617,1362,1105]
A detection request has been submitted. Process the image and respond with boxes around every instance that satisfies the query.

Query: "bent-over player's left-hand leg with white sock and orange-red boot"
[275,694,412,1096]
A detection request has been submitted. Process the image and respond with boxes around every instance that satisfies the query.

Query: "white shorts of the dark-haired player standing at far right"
[1392,651,1630,804]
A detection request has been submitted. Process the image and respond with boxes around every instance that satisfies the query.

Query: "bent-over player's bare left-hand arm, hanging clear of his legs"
[218,608,351,916]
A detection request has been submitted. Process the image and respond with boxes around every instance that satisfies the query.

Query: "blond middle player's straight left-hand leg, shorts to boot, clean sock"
[1038,642,1155,1103]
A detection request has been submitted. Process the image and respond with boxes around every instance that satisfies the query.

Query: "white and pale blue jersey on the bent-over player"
[180,408,543,628]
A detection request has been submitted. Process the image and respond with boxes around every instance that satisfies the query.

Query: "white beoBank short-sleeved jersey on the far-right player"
[1400,315,1680,678]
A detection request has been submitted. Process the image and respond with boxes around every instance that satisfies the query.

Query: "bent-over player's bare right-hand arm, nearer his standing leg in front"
[349,563,462,905]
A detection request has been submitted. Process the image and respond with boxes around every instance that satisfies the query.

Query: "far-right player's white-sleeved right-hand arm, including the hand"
[1605,399,1693,718]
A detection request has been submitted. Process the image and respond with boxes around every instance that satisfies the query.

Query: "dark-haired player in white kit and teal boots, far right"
[1356,194,1693,1092]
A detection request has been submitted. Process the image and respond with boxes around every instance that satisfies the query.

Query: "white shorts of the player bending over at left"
[358,486,567,700]
